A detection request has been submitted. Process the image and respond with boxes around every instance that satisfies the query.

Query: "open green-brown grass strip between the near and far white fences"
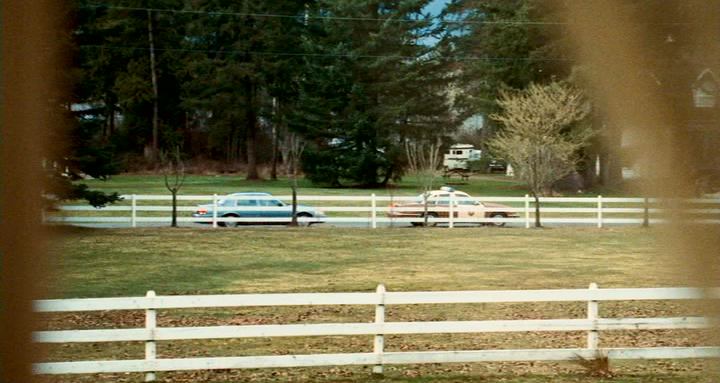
[46,226,682,297]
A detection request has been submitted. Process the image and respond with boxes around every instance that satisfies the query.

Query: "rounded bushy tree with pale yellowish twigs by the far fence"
[489,82,594,227]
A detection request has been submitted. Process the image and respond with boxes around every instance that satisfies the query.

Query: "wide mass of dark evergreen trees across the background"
[66,0,632,190]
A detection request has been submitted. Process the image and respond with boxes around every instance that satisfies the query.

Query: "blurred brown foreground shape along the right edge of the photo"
[562,0,720,372]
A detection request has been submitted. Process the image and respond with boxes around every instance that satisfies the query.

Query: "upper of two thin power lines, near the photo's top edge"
[81,4,569,25]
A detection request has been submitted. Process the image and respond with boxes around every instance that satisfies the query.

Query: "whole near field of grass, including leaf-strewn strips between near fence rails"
[43,226,716,383]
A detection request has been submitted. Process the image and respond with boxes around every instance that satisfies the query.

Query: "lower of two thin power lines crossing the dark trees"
[80,44,574,62]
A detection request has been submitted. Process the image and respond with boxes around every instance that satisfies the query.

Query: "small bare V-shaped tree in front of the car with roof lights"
[405,137,442,226]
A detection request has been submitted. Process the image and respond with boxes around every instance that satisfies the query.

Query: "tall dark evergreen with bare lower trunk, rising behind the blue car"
[184,0,305,179]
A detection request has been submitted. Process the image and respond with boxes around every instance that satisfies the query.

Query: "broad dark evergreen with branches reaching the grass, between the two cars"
[293,0,447,186]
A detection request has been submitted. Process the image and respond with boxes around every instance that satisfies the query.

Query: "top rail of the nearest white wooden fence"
[34,287,720,312]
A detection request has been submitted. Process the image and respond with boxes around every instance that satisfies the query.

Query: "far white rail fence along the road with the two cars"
[46,194,720,228]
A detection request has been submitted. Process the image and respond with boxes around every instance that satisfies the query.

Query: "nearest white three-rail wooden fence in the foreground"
[34,284,720,381]
